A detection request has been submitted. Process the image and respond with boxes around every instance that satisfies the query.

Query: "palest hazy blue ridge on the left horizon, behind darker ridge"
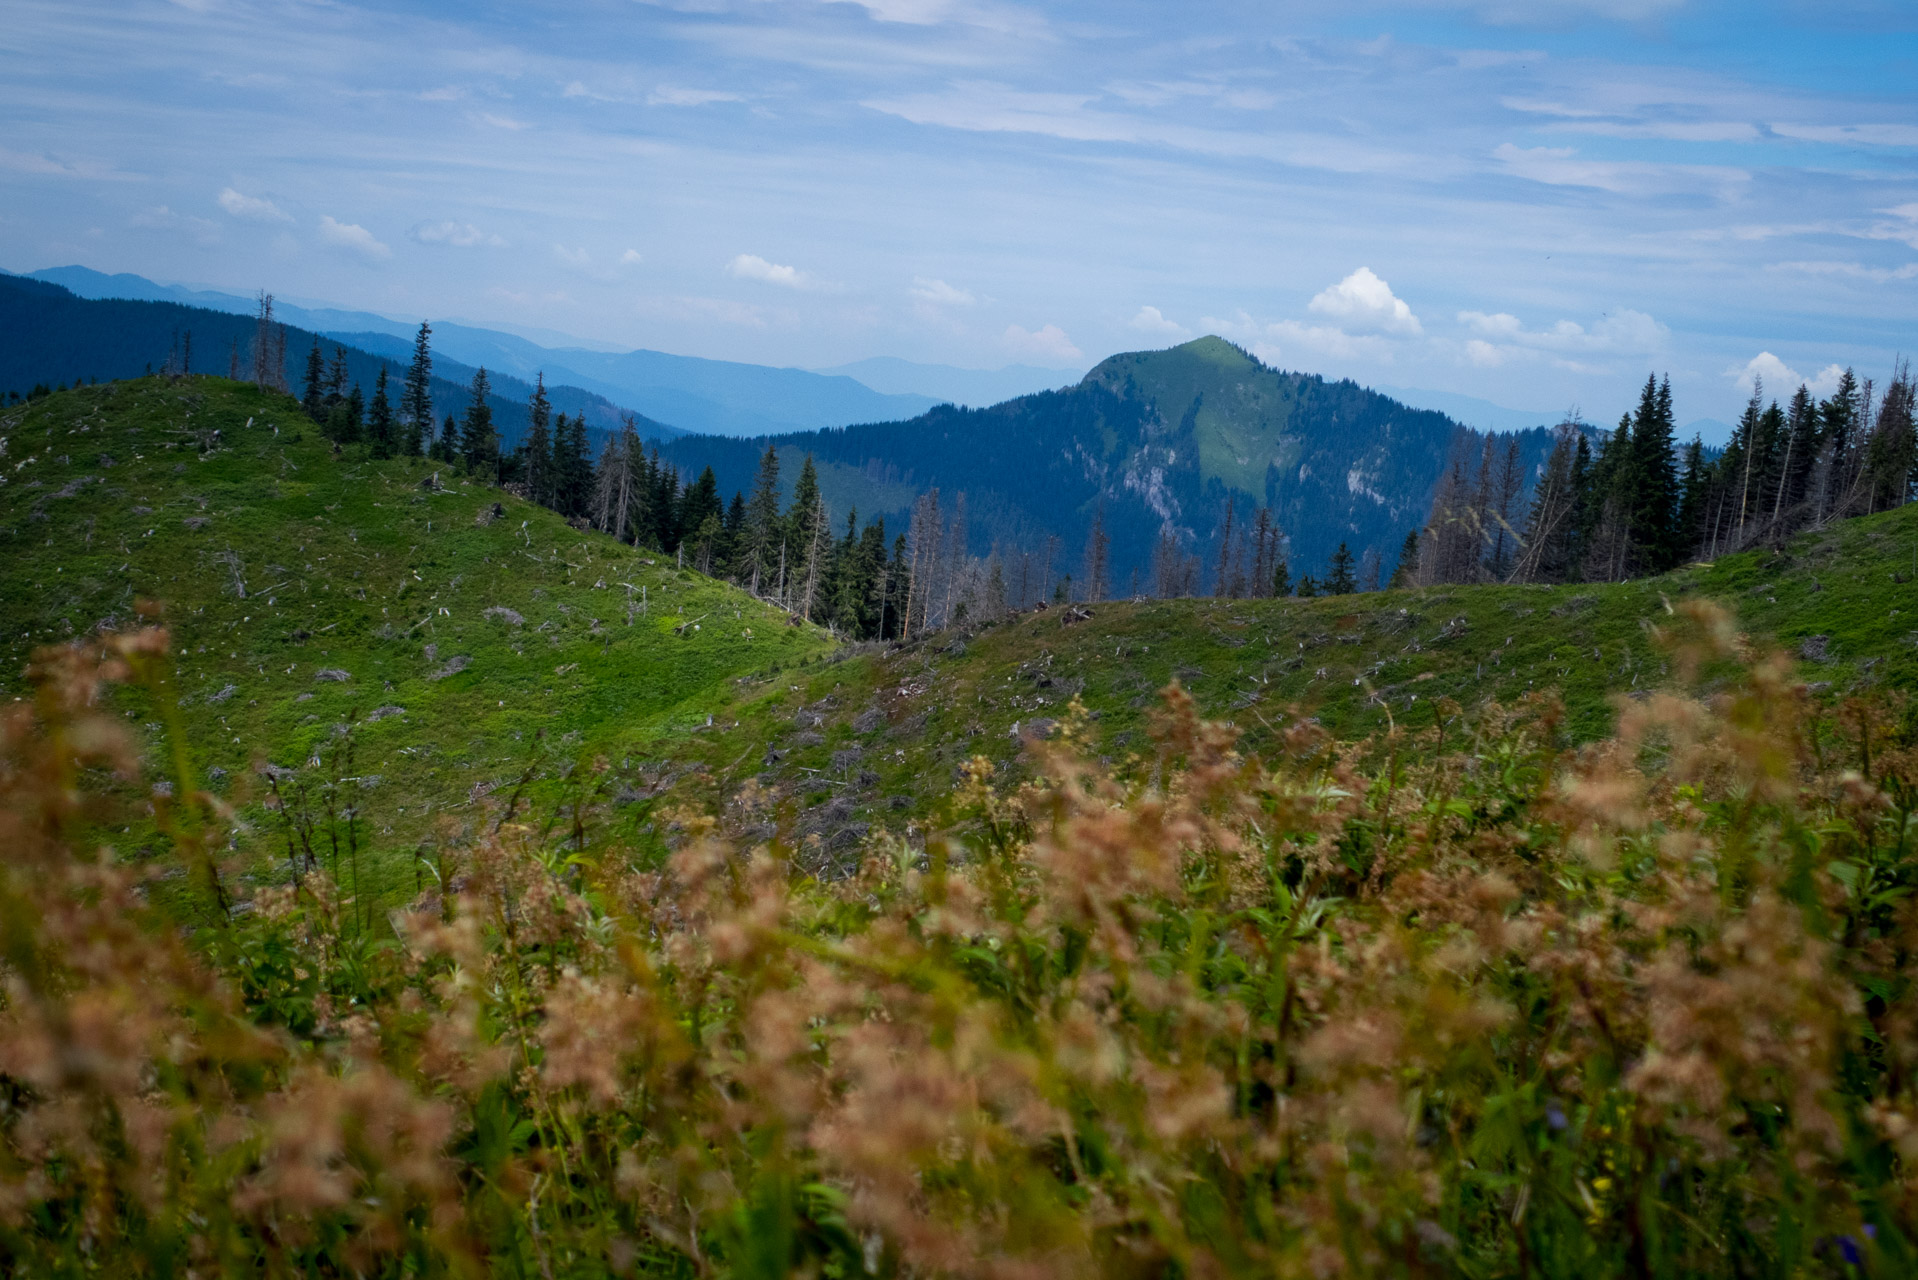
[31,267,935,436]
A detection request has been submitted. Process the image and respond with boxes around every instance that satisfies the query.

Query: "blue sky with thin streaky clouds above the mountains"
[0,0,1918,435]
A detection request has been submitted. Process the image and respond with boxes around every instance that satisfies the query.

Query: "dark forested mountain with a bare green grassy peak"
[662,338,1550,591]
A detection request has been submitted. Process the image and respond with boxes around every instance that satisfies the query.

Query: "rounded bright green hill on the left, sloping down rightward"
[0,378,830,890]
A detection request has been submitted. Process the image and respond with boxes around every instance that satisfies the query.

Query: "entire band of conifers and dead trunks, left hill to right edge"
[287,324,1918,639]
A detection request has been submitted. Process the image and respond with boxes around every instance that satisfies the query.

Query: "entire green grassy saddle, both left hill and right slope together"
[0,378,1918,890]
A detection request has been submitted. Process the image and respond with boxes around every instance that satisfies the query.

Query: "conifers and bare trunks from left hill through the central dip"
[301,322,1426,639]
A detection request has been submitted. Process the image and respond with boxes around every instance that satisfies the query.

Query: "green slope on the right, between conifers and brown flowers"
[655,505,1918,862]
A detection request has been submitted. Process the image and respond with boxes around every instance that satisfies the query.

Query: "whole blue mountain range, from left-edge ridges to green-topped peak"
[11,269,1550,591]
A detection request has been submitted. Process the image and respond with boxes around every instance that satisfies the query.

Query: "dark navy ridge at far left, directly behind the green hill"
[0,274,681,447]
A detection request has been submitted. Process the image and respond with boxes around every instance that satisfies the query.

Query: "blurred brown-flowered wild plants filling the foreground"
[0,606,1918,1276]
